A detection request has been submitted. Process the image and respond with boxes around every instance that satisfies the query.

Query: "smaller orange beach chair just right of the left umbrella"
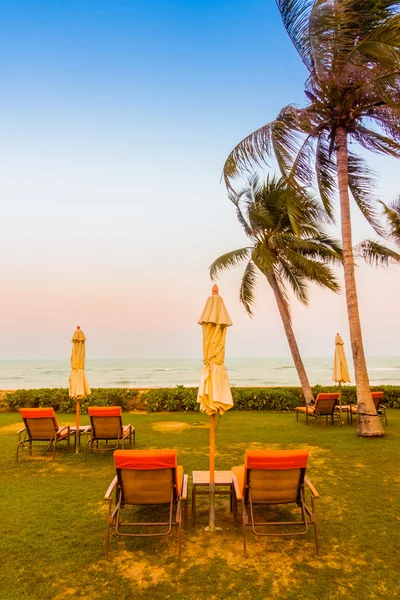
[86,406,135,457]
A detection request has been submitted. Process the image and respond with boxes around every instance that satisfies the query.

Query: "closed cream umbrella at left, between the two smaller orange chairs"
[69,326,90,452]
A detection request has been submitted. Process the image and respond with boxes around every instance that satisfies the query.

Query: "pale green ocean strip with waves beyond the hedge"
[0,357,400,390]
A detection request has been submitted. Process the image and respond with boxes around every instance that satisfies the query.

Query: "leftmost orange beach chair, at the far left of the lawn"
[16,408,75,460]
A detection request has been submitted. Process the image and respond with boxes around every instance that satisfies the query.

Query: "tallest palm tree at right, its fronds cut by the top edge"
[224,0,400,436]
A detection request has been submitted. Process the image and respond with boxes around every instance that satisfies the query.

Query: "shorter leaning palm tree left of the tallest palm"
[210,176,342,403]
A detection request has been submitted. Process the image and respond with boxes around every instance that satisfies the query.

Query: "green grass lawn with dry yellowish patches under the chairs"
[0,409,400,600]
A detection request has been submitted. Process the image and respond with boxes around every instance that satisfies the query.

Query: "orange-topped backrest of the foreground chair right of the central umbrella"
[243,450,308,504]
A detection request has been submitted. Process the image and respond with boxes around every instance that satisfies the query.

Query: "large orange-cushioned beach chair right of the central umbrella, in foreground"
[232,450,319,558]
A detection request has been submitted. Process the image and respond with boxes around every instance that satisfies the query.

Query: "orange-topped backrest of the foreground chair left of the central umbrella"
[114,450,180,505]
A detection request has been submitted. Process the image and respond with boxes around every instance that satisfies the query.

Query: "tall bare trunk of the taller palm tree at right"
[336,127,384,437]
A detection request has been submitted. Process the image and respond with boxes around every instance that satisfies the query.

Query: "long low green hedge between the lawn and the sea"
[6,385,400,414]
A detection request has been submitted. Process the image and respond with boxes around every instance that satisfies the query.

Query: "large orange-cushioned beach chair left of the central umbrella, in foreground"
[104,450,188,558]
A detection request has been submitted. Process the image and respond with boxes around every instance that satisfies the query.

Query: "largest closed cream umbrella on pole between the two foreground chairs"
[197,285,233,531]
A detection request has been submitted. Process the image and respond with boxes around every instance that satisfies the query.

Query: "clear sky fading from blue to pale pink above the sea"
[0,0,400,359]
